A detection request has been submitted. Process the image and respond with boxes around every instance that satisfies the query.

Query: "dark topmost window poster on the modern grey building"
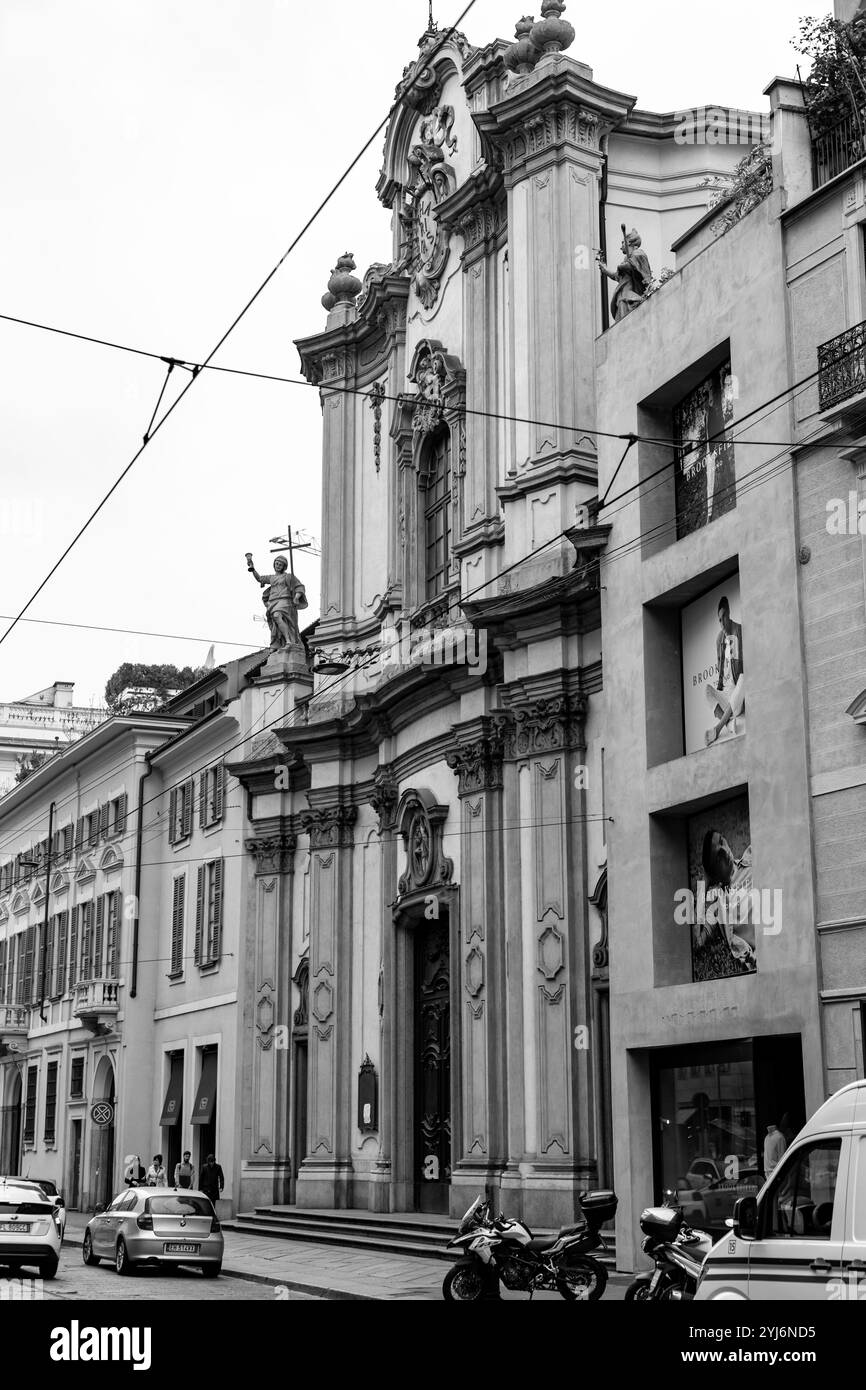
[673,361,737,539]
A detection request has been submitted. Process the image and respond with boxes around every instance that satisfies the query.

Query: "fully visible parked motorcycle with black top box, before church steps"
[442,1191,617,1302]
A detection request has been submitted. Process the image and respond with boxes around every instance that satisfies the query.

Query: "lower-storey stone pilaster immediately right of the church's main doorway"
[446,719,507,1213]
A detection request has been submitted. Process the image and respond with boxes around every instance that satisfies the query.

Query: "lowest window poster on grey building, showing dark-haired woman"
[676,795,756,981]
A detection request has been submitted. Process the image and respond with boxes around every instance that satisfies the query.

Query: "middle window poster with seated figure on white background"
[681,574,745,753]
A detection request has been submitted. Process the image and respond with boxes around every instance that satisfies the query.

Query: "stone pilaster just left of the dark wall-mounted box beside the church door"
[296,802,357,1207]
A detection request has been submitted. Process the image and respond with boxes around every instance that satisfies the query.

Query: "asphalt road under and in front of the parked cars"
[0,1245,314,1302]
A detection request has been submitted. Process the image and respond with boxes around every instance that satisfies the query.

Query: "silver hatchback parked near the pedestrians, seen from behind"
[82,1187,224,1279]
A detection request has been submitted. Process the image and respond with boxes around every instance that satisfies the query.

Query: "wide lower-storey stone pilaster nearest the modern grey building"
[503,678,596,1226]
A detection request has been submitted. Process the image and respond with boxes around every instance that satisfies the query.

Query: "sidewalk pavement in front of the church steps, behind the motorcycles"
[64,1212,631,1302]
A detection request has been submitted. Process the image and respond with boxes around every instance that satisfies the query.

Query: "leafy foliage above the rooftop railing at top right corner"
[791,14,866,135]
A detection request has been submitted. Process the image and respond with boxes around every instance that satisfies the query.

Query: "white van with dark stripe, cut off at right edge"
[695,1080,866,1301]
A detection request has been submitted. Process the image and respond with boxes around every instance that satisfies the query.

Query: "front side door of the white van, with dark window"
[749,1136,851,1300]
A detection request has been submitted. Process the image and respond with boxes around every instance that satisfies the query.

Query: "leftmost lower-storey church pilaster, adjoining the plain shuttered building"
[242,831,296,1205]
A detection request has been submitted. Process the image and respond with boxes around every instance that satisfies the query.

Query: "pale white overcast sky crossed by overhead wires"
[0,0,831,702]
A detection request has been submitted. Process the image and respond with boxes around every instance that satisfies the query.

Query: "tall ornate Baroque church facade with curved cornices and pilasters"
[229,10,750,1226]
